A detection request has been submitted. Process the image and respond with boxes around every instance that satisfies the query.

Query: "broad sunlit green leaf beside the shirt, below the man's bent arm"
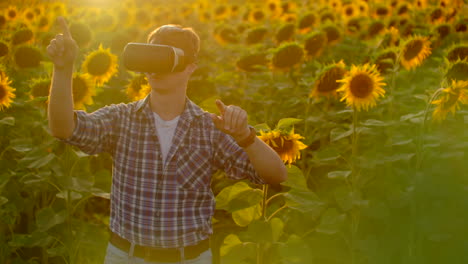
[216,181,263,213]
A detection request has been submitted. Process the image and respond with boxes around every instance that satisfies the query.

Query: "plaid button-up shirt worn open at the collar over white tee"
[63,96,264,248]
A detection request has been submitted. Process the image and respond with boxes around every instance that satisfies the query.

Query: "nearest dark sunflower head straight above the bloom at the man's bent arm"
[272,42,304,70]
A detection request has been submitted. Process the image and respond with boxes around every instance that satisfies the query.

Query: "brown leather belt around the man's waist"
[109,232,210,262]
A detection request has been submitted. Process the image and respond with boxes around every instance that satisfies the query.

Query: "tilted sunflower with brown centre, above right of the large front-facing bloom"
[401,36,431,70]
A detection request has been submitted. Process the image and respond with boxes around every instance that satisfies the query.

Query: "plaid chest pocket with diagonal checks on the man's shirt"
[176,149,212,190]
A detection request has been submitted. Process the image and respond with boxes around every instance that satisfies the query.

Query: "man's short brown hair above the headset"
[147,24,200,65]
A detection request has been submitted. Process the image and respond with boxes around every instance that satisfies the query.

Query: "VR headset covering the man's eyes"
[122,42,185,74]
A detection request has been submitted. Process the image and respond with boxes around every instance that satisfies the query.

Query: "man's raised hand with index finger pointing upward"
[47,17,78,69]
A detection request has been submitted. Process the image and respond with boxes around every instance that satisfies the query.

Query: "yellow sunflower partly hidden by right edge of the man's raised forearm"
[72,73,96,109]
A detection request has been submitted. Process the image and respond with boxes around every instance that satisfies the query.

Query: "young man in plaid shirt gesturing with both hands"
[47,17,287,264]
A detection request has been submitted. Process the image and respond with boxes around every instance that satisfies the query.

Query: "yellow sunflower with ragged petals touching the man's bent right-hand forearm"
[258,129,307,165]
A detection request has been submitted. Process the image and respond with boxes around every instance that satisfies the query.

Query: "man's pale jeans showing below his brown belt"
[104,243,212,264]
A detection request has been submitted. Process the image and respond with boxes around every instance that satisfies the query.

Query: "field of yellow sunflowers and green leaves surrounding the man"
[0,0,468,264]
